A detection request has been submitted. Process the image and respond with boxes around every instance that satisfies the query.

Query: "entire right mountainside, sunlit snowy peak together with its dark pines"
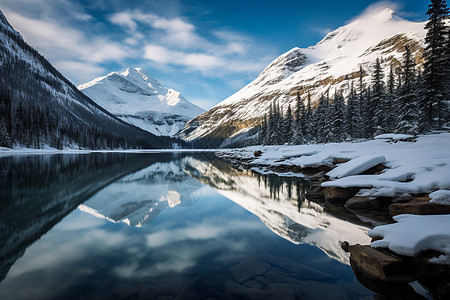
[181,9,448,147]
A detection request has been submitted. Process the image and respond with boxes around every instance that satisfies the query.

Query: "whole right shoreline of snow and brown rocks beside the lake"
[217,133,450,299]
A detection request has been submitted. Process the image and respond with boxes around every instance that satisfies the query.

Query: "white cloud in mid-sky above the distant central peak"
[110,11,269,77]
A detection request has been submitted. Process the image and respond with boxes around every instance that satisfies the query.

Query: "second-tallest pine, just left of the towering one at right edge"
[397,47,419,134]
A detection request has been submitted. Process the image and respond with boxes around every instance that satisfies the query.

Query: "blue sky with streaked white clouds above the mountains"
[0,0,429,109]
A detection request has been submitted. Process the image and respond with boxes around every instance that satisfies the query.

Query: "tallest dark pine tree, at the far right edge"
[421,0,449,128]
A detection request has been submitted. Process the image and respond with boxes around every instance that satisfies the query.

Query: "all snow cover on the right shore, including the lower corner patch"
[218,133,450,257]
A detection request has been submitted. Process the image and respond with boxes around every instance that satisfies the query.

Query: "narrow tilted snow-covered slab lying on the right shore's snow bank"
[326,155,386,178]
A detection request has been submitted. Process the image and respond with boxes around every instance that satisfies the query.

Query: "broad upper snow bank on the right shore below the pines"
[221,133,450,197]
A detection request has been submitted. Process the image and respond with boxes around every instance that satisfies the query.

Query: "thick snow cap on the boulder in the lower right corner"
[369,215,450,256]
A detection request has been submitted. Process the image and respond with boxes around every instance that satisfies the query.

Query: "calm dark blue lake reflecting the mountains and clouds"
[0,153,374,300]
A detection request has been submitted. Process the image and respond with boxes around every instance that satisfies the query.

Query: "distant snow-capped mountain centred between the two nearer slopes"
[78,68,204,136]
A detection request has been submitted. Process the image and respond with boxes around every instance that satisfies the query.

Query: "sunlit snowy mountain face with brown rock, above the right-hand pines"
[180,9,425,140]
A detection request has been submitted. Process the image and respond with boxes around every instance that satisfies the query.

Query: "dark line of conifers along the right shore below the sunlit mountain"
[255,0,450,145]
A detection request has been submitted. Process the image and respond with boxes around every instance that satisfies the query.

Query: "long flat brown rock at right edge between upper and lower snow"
[389,202,450,216]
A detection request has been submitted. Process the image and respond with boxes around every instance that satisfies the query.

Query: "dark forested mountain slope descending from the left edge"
[0,11,177,149]
